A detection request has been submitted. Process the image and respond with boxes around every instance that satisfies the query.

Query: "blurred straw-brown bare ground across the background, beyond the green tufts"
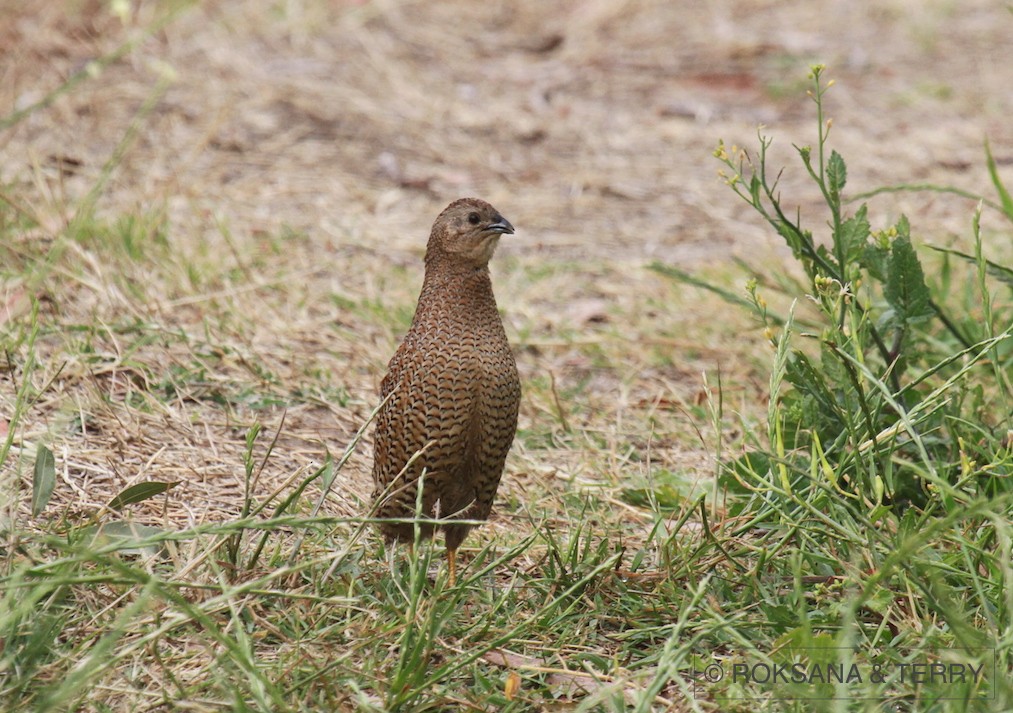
[0,0,1013,262]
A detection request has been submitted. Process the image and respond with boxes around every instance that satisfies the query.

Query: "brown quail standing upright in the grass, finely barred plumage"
[373,199,521,584]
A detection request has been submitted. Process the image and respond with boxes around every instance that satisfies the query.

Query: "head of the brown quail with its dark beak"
[425,199,514,267]
